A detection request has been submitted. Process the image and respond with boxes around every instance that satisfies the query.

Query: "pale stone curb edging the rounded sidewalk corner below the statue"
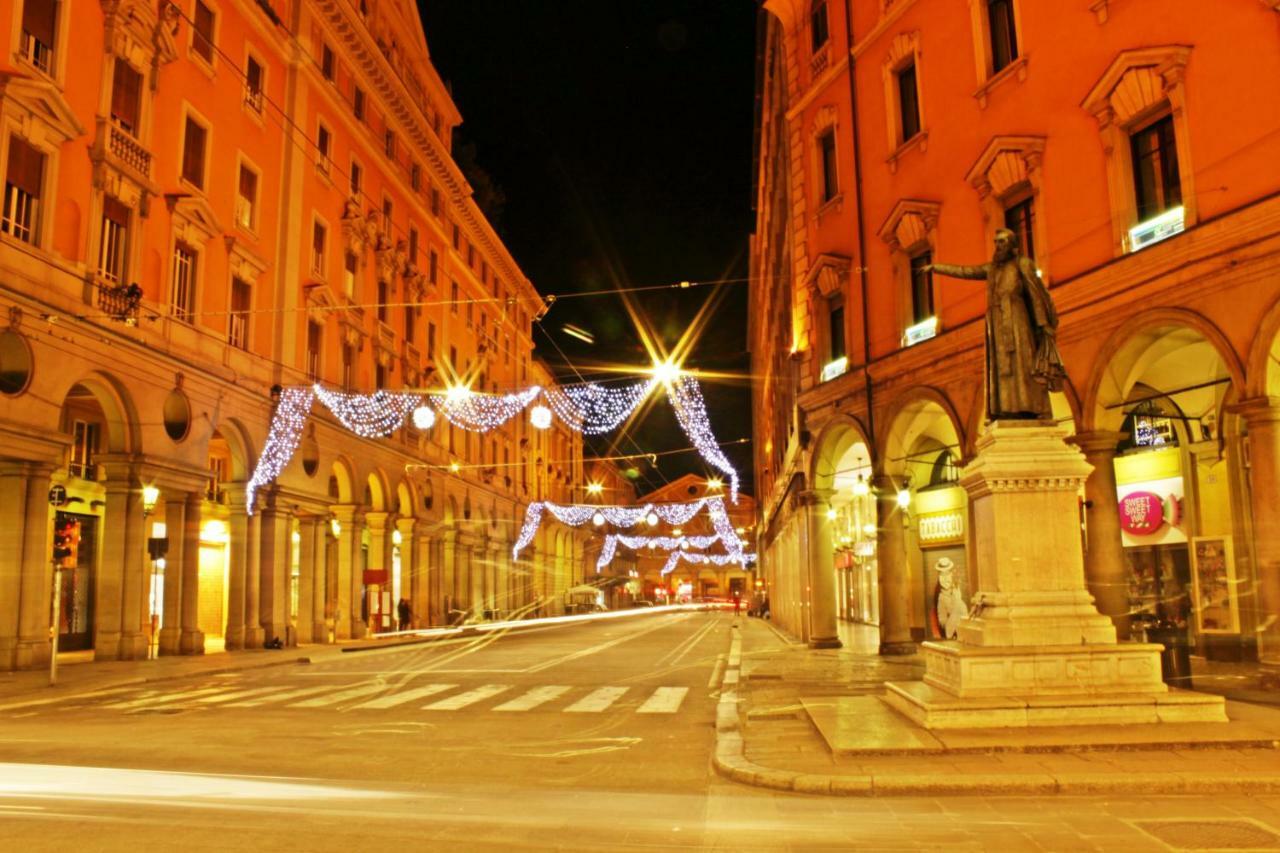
[712,626,1280,797]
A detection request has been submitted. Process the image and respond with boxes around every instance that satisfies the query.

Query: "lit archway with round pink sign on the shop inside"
[1087,318,1244,660]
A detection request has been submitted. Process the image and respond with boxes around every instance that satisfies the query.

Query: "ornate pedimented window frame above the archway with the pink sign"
[1080,45,1198,256]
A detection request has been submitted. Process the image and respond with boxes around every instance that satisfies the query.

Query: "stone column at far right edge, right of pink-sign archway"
[1233,397,1280,663]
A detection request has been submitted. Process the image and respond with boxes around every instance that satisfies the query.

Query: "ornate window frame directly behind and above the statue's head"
[964,136,1050,274]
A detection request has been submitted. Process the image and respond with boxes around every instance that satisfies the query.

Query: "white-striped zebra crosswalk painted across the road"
[64,680,689,715]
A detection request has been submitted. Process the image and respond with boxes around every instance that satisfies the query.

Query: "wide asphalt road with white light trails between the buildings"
[0,612,1280,850]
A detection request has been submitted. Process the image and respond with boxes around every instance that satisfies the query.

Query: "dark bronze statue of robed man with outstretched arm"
[924,228,1066,420]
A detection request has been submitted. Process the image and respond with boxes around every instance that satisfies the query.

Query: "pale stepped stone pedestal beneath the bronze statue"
[884,421,1226,729]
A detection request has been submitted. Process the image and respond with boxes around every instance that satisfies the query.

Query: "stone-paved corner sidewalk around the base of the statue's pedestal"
[714,619,1280,797]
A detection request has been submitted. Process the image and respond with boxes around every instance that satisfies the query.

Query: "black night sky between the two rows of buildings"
[419,0,755,492]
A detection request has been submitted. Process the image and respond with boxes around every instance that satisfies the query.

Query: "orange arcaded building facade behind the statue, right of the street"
[750,0,1280,660]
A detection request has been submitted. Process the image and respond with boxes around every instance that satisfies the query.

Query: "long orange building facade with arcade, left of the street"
[0,0,582,669]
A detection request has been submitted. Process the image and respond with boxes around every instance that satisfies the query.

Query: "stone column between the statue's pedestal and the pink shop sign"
[1069,430,1129,639]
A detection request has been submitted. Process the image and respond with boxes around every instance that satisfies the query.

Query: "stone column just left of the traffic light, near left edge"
[15,464,54,670]
